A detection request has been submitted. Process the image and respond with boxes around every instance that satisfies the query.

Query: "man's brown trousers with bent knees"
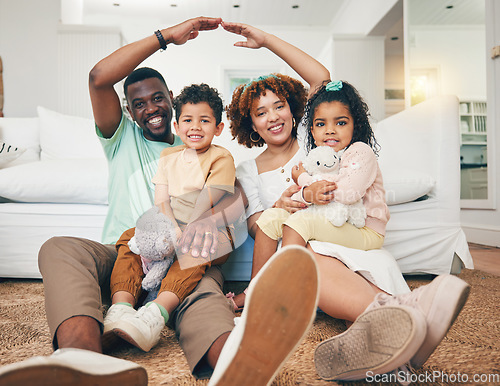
[38,237,234,377]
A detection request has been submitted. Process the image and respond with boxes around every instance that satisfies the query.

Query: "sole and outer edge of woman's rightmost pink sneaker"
[410,275,470,368]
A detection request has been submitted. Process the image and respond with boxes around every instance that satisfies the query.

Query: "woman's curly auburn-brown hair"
[226,74,307,148]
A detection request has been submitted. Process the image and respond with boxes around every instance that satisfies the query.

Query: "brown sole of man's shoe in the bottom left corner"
[0,365,148,386]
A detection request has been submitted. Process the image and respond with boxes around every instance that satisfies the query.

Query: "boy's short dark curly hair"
[173,83,224,125]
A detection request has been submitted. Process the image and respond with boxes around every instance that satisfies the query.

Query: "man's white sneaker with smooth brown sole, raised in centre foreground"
[209,246,319,386]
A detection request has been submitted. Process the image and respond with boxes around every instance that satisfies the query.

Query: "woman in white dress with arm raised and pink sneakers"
[222,22,469,380]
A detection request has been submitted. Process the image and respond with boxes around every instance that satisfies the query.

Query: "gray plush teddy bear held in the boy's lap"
[128,206,176,301]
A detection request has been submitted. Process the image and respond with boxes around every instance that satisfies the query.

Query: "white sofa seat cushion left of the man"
[0,158,108,204]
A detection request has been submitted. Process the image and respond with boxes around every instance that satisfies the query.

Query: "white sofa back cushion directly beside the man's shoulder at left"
[38,106,105,160]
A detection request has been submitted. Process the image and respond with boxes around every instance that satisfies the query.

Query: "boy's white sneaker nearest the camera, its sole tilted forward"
[113,303,165,352]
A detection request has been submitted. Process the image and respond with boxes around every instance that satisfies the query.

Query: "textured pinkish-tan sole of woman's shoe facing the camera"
[314,306,426,381]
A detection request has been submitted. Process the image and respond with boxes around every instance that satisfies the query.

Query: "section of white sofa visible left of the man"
[0,107,108,278]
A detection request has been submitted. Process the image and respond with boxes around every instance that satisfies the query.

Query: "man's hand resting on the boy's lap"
[179,217,218,258]
